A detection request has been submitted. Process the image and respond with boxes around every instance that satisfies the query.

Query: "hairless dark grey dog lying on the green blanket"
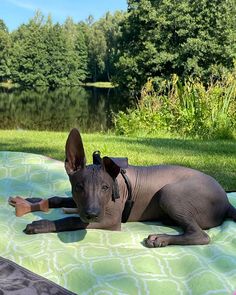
[20,129,236,247]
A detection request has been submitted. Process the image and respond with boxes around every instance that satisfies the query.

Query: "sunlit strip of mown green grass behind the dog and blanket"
[0,130,236,191]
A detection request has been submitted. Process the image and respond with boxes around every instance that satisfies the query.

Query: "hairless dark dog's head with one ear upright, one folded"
[65,129,128,223]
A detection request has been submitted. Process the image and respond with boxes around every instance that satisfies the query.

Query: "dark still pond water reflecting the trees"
[0,87,127,132]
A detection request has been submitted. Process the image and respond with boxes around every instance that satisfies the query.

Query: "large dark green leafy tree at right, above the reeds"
[115,0,235,92]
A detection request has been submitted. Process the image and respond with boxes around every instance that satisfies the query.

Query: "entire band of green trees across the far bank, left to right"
[0,0,236,93]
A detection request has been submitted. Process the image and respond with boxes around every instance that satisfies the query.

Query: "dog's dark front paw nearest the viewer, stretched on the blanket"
[23,220,56,235]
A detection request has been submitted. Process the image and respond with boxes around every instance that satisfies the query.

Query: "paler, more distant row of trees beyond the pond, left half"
[0,11,124,88]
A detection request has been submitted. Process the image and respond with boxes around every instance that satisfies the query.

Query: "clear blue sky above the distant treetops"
[0,0,127,31]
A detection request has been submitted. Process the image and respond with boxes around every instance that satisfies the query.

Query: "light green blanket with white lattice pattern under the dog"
[0,152,236,295]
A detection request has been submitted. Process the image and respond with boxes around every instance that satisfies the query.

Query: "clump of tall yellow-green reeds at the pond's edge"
[114,72,236,139]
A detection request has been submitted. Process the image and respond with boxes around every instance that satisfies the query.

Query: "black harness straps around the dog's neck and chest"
[93,151,134,223]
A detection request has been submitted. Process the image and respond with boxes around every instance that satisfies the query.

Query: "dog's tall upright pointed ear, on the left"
[65,128,86,174]
